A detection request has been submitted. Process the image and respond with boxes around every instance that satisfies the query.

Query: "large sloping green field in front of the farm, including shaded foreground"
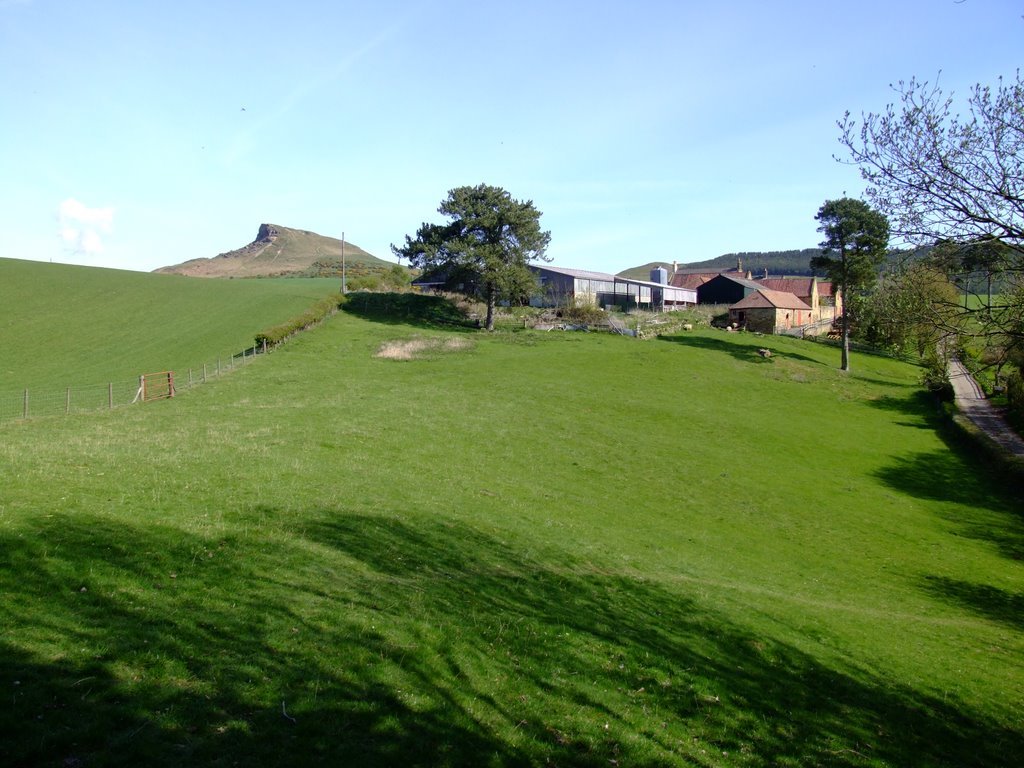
[0,303,1024,767]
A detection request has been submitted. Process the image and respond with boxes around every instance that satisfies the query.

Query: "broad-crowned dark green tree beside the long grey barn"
[391,184,551,331]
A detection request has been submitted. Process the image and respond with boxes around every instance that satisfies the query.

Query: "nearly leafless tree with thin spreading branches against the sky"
[839,72,1024,348]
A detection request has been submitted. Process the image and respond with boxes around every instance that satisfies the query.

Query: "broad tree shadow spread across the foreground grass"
[0,510,1024,767]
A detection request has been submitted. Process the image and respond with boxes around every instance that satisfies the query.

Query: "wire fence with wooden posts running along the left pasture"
[0,344,267,422]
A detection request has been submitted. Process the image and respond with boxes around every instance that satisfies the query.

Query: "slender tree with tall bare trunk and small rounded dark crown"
[811,198,889,371]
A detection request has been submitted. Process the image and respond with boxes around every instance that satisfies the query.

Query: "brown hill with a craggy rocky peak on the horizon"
[154,224,394,278]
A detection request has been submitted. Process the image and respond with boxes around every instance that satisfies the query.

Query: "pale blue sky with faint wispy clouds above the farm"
[0,0,1024,271]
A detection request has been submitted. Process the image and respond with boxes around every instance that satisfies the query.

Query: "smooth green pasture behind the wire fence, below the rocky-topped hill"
[0,258,340,395]
